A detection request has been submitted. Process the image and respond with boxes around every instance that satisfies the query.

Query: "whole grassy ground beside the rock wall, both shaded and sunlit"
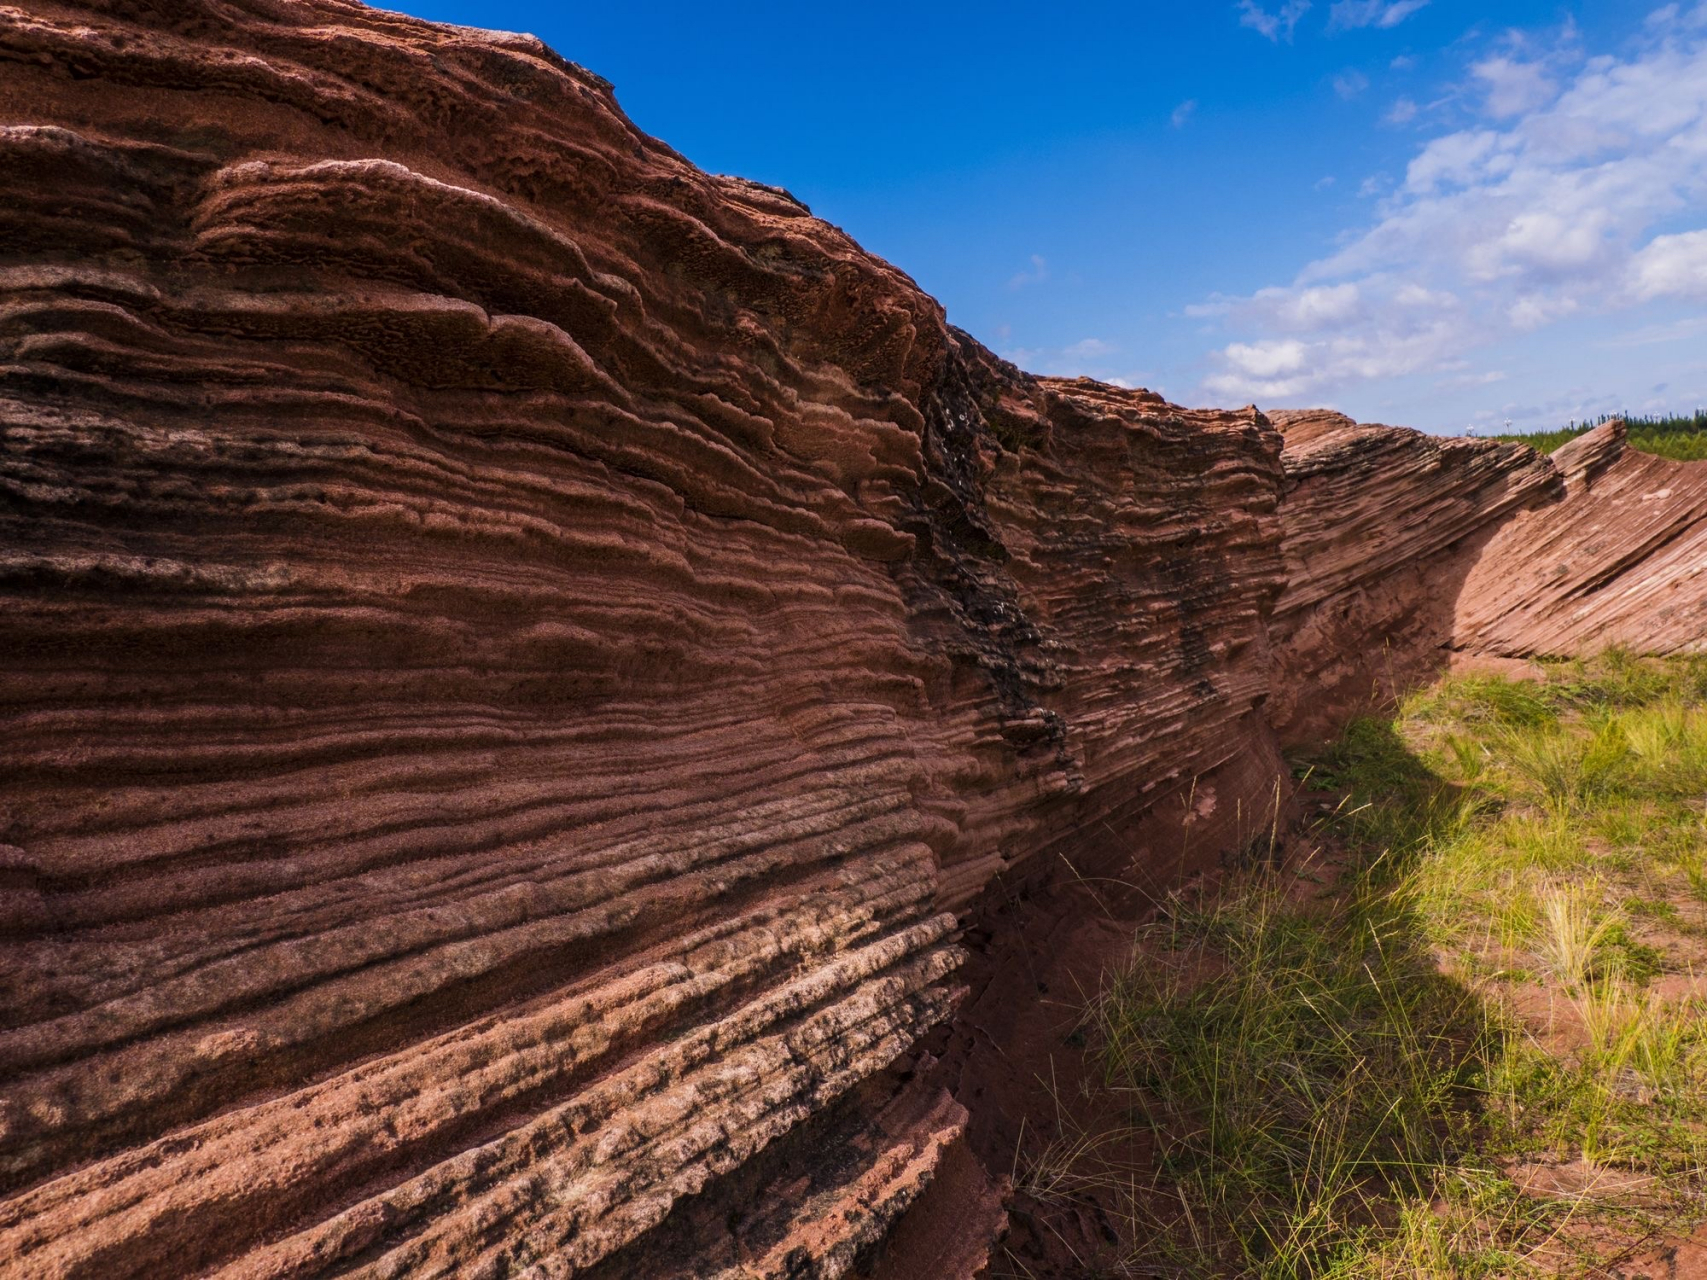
[1033,652,1707,1280]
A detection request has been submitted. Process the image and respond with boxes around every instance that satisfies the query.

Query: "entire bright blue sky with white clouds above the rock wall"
[401,0,1707,432]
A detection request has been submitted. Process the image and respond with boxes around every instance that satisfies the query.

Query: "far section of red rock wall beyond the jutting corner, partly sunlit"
[1268,411,1707,741]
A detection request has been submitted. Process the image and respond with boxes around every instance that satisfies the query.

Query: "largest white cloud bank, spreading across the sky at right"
[1197,20,1707,416]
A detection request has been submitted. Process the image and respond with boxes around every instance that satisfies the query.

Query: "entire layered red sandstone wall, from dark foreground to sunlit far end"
[0,0,1707,1280]
